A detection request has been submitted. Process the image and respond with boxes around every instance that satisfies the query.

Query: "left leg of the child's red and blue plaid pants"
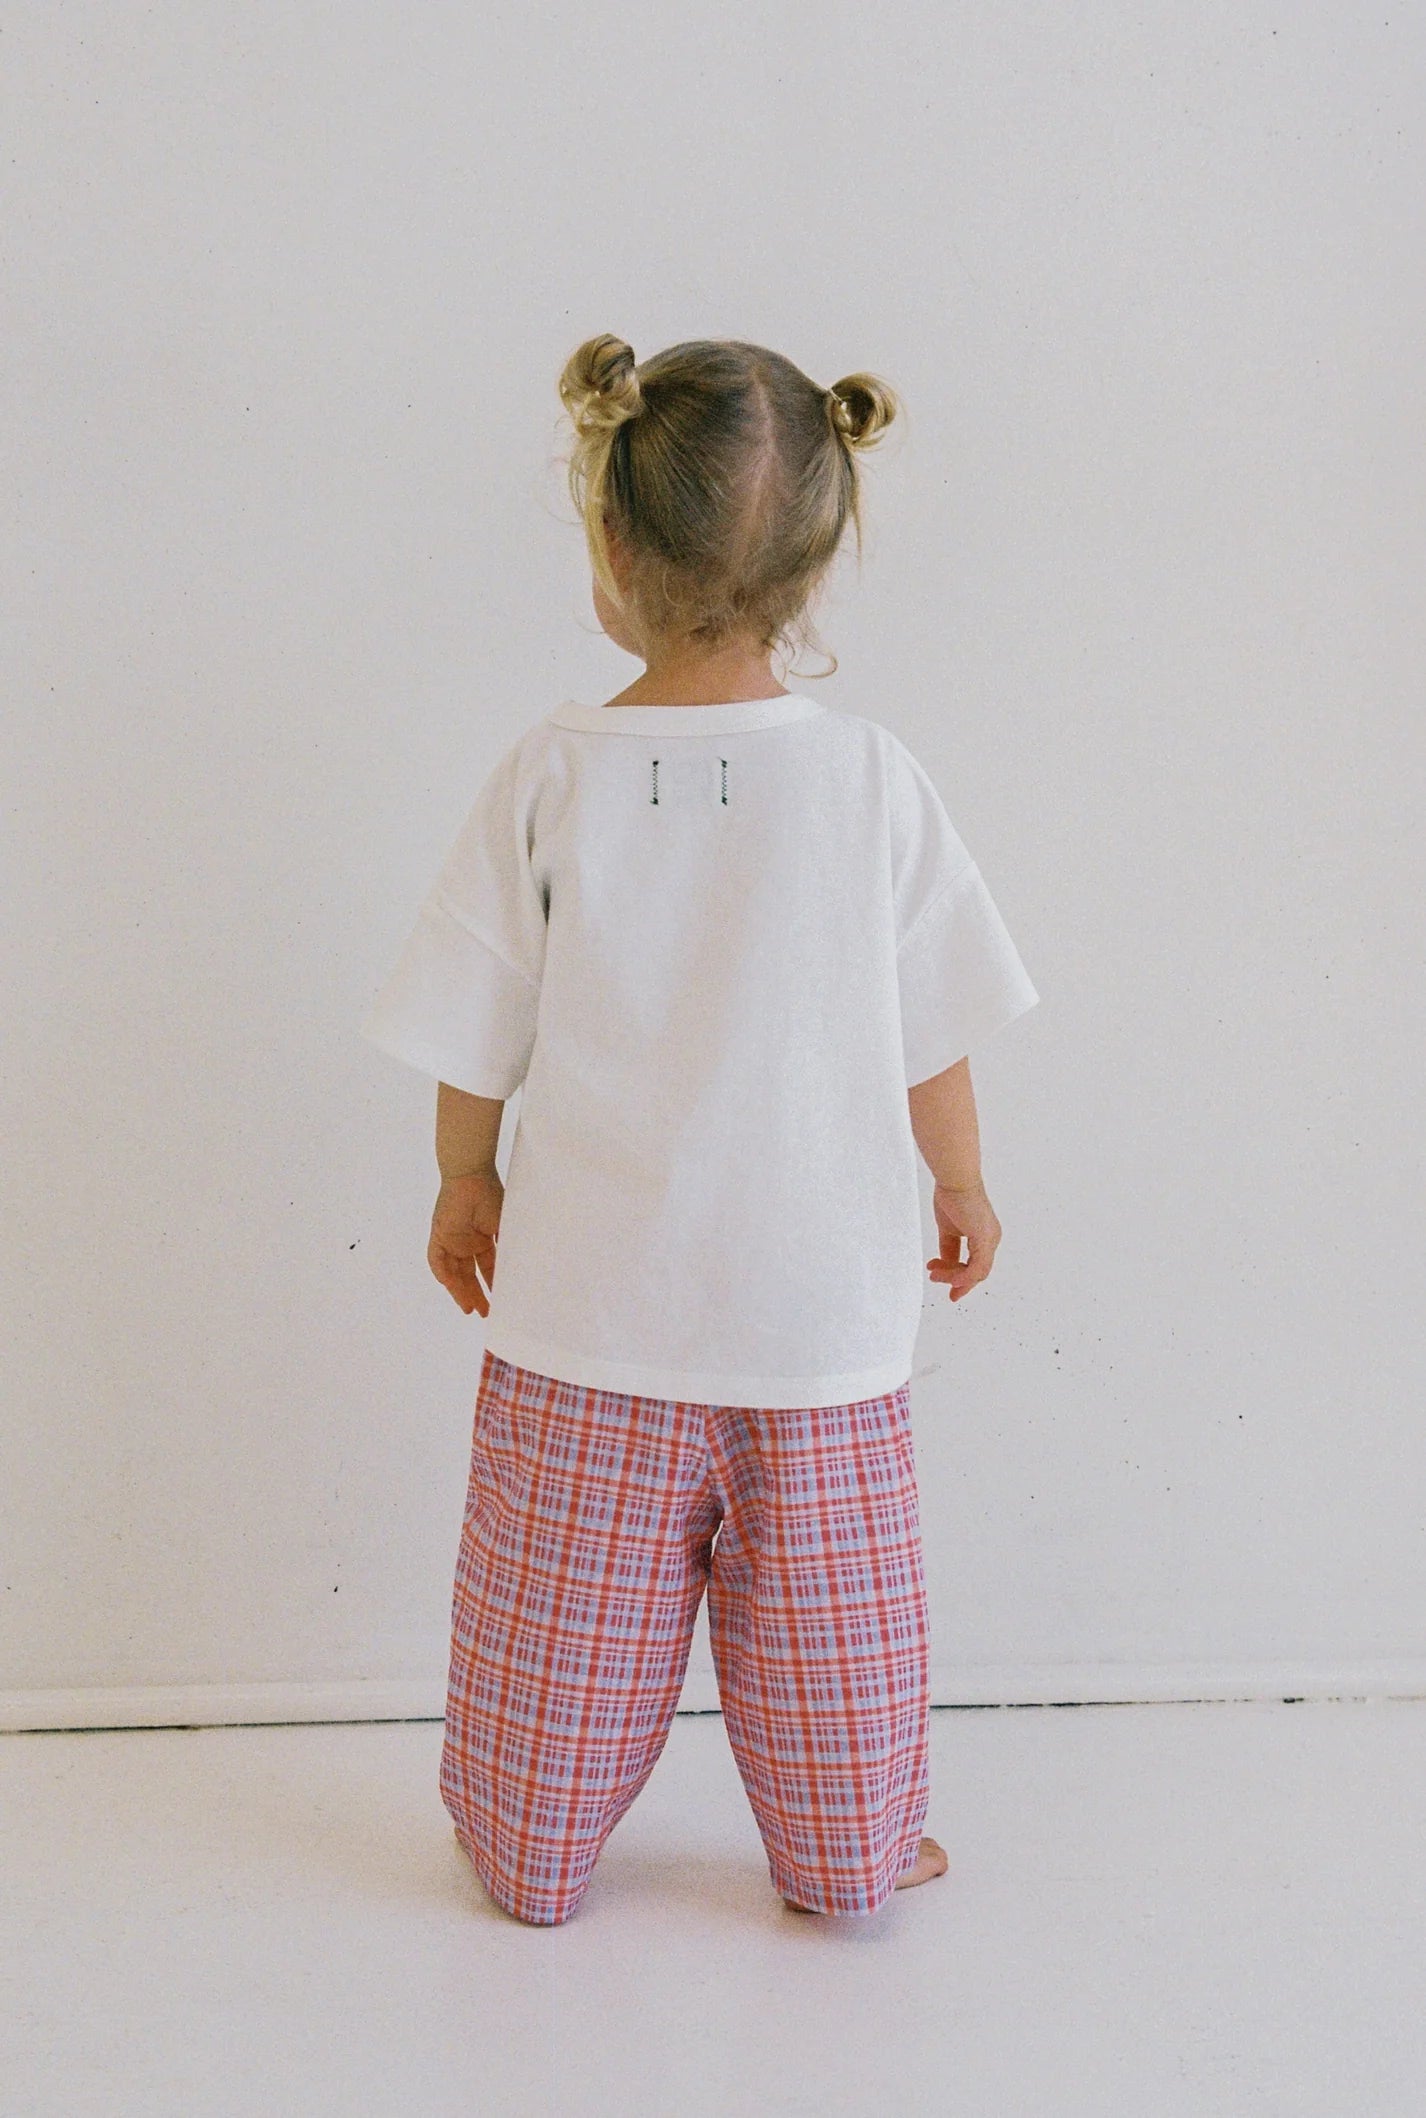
[441,1351,718,1925]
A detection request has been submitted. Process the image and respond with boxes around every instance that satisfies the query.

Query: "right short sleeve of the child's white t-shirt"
[888,739,1040,1089]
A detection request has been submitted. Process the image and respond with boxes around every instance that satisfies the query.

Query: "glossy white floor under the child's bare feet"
[0,1701,1426,2118]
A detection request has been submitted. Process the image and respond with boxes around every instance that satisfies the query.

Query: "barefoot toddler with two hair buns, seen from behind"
[362,335,1038,1925]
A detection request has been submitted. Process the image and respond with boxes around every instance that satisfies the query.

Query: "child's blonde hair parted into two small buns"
[559,333,901,676]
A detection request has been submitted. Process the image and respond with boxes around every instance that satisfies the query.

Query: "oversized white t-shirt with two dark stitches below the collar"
[360,693,1038,1406]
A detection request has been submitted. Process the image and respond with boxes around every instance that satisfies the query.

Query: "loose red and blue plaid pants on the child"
[441,1351,930,1925]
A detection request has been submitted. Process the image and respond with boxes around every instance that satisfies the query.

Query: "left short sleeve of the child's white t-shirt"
[360,739,549,1101]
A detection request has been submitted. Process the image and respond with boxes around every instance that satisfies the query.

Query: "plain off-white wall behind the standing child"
[0,0,1426,1726]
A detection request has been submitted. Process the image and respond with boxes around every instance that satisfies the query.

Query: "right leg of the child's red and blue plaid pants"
[708,1383,930,1913]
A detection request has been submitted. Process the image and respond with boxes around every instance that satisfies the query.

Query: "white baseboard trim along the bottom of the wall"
[0,1658,1426,1735]
